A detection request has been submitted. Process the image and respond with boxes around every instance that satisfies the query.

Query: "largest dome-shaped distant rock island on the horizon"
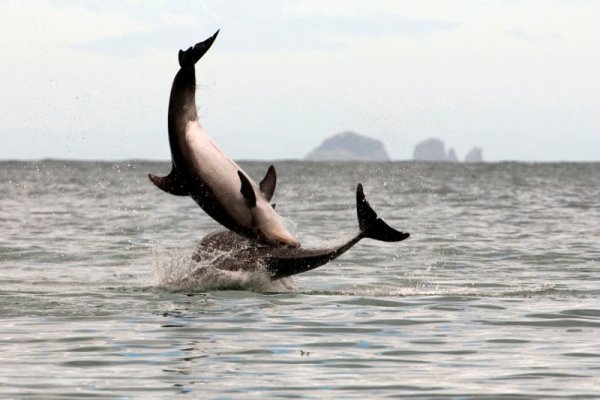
[305,131,390,161]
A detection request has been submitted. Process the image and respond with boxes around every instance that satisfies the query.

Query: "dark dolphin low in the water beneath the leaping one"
[192,183,410,280]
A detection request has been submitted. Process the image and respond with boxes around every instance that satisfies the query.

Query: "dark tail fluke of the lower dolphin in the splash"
[356,183,410,242]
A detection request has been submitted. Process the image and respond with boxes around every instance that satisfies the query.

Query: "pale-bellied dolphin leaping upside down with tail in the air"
[148,31,300,247]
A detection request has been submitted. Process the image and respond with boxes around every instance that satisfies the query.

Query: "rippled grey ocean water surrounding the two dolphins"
[0,161,600,399]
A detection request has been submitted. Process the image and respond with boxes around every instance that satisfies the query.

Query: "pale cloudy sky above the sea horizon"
[0,0,600,161]
